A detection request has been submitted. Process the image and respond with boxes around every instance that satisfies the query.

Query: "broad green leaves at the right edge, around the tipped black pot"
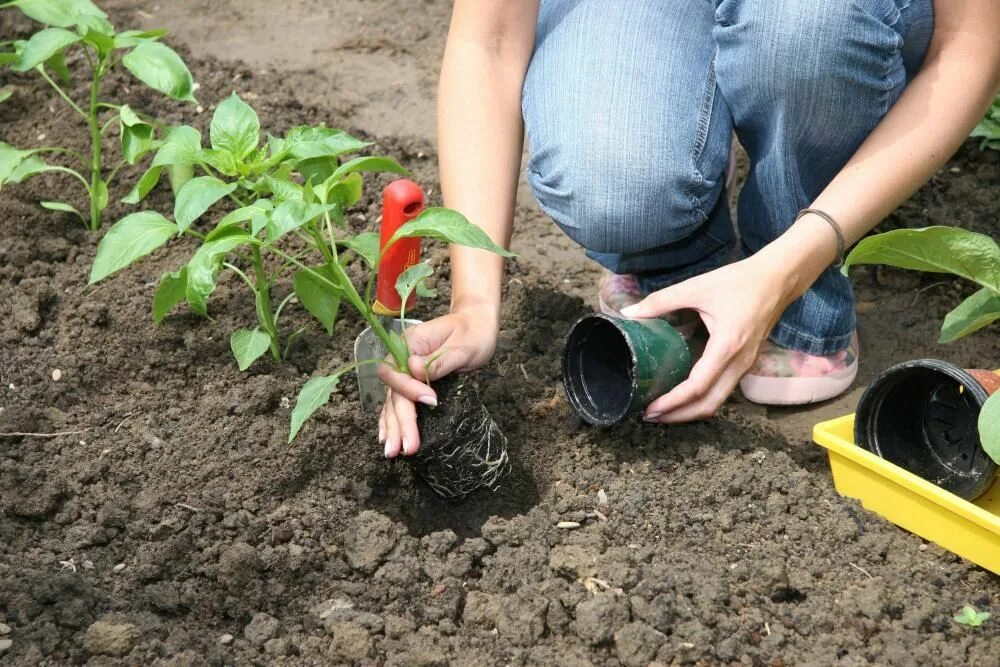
[843,227,1000,464]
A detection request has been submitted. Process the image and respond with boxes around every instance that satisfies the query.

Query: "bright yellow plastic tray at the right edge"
[813,415,1000,574]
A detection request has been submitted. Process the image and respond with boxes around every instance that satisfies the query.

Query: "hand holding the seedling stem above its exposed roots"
[378,306,497,459]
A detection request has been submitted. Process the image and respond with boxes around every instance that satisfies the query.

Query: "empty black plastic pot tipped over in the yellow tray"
[854,359,1000,500]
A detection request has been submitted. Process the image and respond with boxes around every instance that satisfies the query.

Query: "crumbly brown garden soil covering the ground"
[0,0,1000,666]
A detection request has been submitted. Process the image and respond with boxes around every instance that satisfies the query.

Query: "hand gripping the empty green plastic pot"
[622,255,798,424]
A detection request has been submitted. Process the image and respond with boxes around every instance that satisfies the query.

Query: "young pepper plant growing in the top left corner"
[0,0,195,231]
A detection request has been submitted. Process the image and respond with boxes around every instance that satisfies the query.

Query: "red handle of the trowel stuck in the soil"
[372,178,424,317]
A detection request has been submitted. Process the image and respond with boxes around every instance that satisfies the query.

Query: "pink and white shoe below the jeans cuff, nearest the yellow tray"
[740,332,860,405]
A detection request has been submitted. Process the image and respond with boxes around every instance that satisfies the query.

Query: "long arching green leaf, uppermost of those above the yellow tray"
[842,227,1000,292]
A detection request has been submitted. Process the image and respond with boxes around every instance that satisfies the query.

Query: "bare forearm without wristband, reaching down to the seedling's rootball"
[438,15,530,315]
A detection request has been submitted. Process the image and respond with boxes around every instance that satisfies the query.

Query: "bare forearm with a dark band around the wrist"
[765,5,1000,296]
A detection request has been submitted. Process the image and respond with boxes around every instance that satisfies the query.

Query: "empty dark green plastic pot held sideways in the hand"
[563,313,691,426]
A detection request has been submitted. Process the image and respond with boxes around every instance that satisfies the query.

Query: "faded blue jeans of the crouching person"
[522,0,934,354]
